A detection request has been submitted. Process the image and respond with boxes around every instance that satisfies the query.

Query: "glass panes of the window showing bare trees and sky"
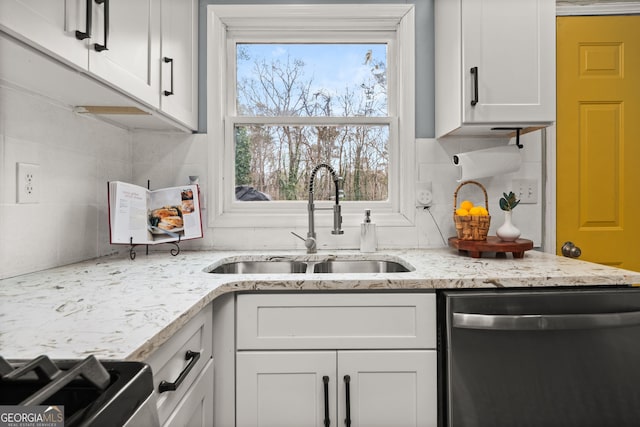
[234,43,390,201]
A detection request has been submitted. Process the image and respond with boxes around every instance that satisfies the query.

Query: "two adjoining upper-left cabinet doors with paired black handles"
[0,0,160,107]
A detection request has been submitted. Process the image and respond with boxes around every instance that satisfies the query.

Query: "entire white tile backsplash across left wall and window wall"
[0,86,542,278]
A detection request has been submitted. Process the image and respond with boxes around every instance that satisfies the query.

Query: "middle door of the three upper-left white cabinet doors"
[89,0,160,107]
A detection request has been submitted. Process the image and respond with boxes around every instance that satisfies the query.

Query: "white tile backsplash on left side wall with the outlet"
[0,86,132,278]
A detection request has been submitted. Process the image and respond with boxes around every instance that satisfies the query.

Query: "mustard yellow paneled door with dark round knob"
[556,16,640,271]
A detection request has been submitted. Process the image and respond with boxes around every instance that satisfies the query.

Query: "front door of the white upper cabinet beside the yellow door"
[461,0,555,123]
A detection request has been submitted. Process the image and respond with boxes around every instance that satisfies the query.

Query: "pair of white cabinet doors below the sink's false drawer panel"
[236,350,437,427]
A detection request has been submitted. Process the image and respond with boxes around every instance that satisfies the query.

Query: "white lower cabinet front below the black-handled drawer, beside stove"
[164,359,213,427]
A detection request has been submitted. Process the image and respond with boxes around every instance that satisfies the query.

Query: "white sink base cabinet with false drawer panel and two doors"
[235,293,437,427]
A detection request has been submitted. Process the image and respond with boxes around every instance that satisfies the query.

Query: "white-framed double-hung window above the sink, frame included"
[207,4,415,231]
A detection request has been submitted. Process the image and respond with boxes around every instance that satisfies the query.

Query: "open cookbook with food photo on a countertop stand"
[108,181,203,245]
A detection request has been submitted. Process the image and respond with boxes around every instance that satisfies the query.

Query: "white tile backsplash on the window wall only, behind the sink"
[133,132,543,254]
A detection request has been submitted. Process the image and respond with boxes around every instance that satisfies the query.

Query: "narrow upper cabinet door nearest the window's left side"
[160,0,198,129]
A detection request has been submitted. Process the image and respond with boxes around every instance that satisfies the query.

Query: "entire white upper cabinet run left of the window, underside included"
[0,0,198,131]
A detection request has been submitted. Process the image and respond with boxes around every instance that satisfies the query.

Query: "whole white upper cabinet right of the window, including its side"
[435,0,555,137]
